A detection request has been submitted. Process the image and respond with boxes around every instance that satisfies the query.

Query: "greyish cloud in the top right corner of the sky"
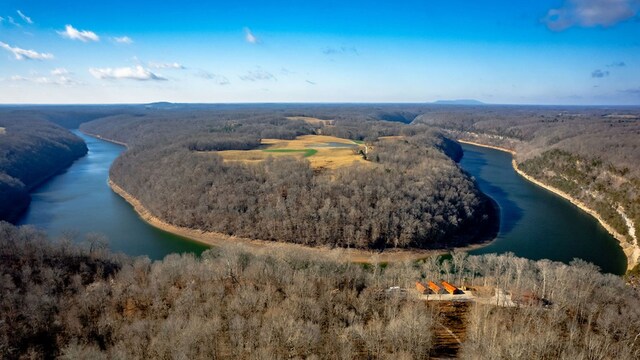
[542,0,640,31]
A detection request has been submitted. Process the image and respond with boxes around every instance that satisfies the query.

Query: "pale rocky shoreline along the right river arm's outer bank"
[457,140,640,271]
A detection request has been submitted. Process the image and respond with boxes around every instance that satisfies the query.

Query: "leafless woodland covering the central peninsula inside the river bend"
[81,109,496,249]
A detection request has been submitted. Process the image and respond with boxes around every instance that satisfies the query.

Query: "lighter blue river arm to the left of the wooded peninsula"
[19,131,207,259]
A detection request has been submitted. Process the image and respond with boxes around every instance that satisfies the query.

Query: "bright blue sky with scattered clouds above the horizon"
[0,0,640,105]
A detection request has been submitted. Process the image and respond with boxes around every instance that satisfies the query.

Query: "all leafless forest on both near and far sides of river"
[0,104,640,359]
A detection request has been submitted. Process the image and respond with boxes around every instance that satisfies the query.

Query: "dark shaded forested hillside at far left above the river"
[0,116,87,220]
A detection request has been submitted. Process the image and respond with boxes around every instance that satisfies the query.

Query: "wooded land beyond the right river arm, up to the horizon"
[416,106,640,252]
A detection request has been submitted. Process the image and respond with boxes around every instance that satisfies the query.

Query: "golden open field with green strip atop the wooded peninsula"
[218,135,371,170]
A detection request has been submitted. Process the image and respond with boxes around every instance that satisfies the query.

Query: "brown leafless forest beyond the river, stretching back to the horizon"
[0,103,640,248]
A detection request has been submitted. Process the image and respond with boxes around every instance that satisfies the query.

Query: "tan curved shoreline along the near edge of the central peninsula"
[108,178,494,264]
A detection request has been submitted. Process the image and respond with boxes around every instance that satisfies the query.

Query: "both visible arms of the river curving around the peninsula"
[19,131,626,274]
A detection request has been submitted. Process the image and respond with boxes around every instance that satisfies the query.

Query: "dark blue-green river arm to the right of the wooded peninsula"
[460,144,626,274]
